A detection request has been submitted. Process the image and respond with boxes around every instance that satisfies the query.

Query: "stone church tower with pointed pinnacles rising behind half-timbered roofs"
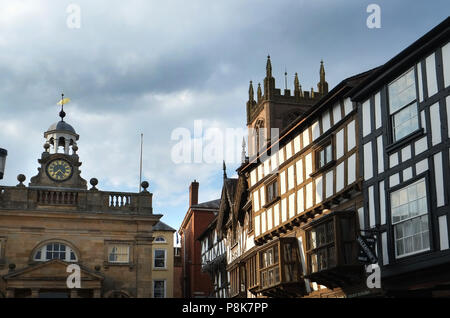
[247,56,328,158]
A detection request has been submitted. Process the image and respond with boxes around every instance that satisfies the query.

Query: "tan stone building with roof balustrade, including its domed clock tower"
[0,110,161,298]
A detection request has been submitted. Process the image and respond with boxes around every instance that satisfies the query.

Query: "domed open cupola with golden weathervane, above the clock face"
[44,95,80,155]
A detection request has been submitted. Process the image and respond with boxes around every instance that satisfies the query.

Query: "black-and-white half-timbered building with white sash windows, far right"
[353,18,450,296]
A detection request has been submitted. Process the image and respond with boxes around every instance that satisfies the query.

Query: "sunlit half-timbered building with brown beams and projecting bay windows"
[236,55,384,297]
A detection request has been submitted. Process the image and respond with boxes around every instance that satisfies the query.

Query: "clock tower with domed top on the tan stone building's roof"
[29,106,87,190]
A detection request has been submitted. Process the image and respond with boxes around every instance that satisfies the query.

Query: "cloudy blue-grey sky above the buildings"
[0,0,450,229]
